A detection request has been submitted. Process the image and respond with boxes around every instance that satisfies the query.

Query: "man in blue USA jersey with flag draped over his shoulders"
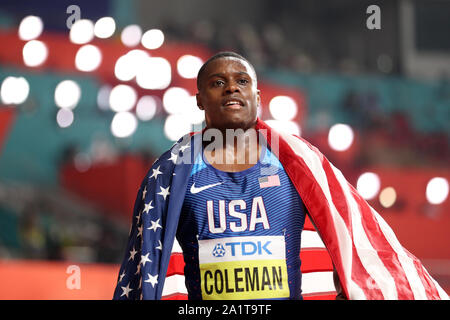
[114,52,448,299]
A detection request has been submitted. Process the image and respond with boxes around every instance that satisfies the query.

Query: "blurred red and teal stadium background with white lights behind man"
[0,0,450,299]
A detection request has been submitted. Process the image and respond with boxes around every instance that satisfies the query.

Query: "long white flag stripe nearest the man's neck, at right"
[280,134,367,300]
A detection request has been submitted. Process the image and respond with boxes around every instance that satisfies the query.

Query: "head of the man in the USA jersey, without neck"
[197,57,260,130]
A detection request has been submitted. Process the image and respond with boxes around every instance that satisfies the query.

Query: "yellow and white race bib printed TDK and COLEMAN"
[198,236,289,300]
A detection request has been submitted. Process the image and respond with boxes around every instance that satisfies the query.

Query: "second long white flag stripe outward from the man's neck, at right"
[331,166,398,300]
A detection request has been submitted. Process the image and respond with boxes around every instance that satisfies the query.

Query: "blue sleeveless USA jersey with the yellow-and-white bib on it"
[177,149,305,300]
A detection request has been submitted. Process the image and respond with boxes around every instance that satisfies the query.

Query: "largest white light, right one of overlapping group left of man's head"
[136,57,172,90]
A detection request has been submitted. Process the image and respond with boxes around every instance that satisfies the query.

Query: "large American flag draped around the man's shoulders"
[114,119,448,300]
